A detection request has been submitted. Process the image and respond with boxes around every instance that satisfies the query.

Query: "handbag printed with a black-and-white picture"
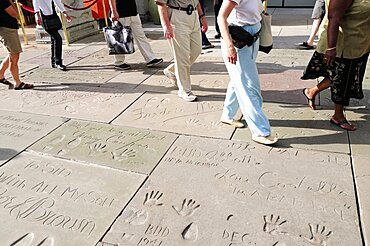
[103,21,135,55]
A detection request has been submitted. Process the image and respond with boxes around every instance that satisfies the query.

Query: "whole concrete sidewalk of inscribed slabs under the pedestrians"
[0,9,370,246]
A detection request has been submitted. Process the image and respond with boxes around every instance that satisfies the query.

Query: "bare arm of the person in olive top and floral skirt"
[325,0,353,65]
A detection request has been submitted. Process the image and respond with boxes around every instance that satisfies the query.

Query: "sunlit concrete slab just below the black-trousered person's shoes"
[22,68,119,86]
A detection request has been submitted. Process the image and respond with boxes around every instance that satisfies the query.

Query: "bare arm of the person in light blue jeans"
[217,0,237,64]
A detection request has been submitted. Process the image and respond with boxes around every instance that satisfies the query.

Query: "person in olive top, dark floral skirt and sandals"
[301,0,370,131]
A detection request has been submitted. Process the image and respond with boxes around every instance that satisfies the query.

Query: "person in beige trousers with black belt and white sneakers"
[156,0,208,102]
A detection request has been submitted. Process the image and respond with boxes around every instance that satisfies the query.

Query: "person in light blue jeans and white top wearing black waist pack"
[218,0,278,145]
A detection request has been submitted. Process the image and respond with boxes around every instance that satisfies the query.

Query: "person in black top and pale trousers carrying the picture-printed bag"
[109,0,163,70]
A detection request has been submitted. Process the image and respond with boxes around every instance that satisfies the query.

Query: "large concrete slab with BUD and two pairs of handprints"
[101,136,362,246]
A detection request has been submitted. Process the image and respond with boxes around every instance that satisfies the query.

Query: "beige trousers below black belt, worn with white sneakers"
[167,10,202,92]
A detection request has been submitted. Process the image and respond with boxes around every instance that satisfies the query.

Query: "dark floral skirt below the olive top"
[301,51,369,106]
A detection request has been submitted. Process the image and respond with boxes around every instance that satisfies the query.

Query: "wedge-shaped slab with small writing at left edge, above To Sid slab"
[0,110,66,166]
